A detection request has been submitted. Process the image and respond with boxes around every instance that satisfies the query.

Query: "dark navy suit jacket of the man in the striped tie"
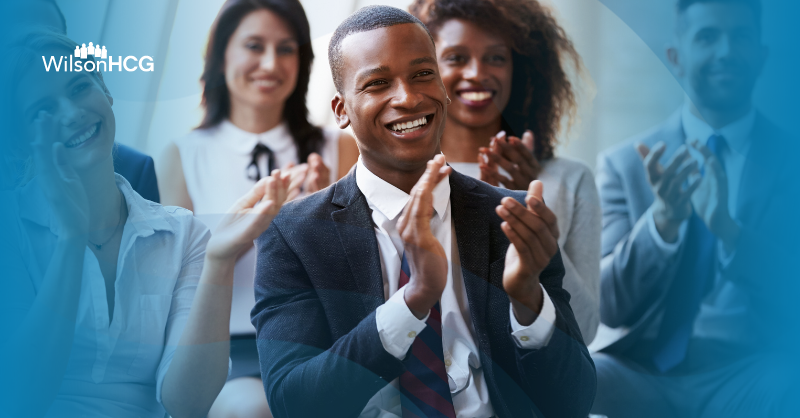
[252,169,596,418]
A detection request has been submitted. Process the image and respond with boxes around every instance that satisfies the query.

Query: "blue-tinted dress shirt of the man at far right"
[645,103,763,344]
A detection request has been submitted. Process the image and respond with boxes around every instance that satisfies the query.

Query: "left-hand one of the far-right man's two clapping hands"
[636,142,700,242]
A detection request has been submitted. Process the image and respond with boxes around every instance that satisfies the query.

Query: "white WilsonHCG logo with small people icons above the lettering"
[42,42,155,72]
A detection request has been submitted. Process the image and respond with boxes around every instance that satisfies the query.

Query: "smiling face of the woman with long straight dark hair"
[225,9,300,112]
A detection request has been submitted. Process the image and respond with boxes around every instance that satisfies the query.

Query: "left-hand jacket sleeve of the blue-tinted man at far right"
[596,154,681,328]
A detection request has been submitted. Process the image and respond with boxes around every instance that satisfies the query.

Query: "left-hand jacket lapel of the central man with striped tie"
[331,169,385,314]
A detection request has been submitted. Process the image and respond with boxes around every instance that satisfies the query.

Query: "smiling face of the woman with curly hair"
[436,19,513,128]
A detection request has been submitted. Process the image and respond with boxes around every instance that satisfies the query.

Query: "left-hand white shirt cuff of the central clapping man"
[375,287,430,360]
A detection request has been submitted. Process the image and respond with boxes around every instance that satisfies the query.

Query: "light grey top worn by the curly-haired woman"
[449,158,603,345]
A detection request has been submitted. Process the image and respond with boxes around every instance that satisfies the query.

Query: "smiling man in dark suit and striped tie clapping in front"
[252,6,595,418]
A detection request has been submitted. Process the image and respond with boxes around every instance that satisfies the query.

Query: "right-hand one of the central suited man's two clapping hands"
[495,180,559,325]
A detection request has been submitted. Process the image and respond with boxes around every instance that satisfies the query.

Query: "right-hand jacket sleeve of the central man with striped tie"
[509,251,597,418]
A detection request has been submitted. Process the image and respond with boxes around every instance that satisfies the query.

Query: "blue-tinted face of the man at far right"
[668,3,767,110]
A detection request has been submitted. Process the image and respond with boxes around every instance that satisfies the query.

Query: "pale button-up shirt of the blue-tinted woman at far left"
[0,174,210,418]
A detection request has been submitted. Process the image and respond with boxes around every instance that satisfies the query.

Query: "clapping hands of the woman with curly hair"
[478,130,542,190]
